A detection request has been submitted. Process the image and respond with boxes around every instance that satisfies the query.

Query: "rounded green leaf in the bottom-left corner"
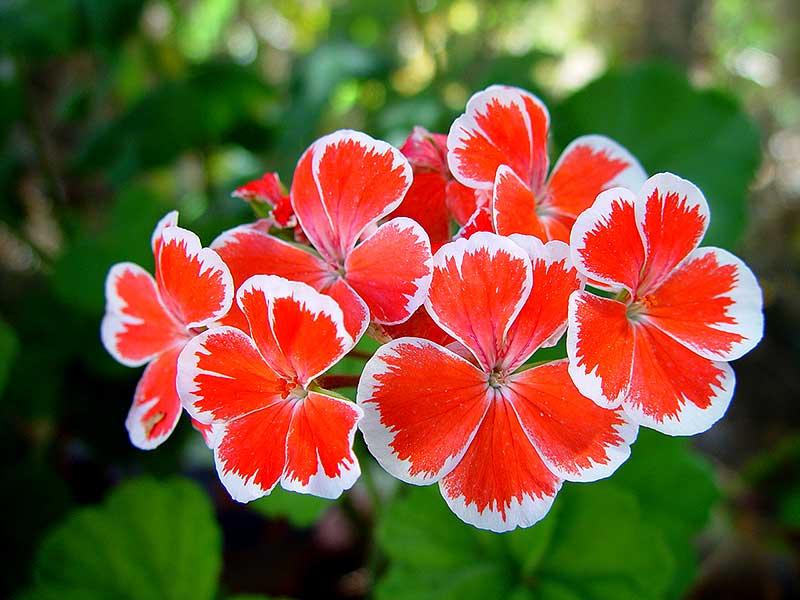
[25,479,221,600]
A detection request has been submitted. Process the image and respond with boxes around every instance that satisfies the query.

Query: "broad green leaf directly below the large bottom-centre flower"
[376,482,673,600]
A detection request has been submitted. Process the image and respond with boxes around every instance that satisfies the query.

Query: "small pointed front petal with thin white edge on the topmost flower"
[492,165,547,241]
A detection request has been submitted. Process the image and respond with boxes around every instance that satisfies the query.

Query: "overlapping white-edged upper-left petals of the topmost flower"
[447,86,549,189]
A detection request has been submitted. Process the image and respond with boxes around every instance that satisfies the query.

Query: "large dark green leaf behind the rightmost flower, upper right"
[553,64,761,248]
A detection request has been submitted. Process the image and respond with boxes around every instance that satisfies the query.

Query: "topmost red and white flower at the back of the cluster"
[447,85,646,242]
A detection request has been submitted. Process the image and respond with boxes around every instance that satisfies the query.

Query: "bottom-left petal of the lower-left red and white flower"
[214,400,294,502]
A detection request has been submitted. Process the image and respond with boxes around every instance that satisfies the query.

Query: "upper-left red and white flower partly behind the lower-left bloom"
[212,130,431,339]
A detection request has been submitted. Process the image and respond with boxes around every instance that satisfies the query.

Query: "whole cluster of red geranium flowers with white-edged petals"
[101,86,763,532]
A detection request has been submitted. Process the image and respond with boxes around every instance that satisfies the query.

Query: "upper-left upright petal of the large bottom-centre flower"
[425,232,531,371]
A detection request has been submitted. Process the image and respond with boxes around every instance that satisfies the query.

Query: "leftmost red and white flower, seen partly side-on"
[100,212,234,450]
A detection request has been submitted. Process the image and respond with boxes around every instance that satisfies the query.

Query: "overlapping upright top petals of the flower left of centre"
[292,130,412,262]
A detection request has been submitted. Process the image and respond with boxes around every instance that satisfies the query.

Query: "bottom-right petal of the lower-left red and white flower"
[281,392,363,498]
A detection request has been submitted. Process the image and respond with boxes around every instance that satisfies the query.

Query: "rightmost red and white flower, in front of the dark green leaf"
[567,173,763,435]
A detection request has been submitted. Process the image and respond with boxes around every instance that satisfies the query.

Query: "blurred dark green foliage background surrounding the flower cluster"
[0,0,800,600]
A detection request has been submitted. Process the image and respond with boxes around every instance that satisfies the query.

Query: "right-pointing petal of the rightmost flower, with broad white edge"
[644,248,764,361]
